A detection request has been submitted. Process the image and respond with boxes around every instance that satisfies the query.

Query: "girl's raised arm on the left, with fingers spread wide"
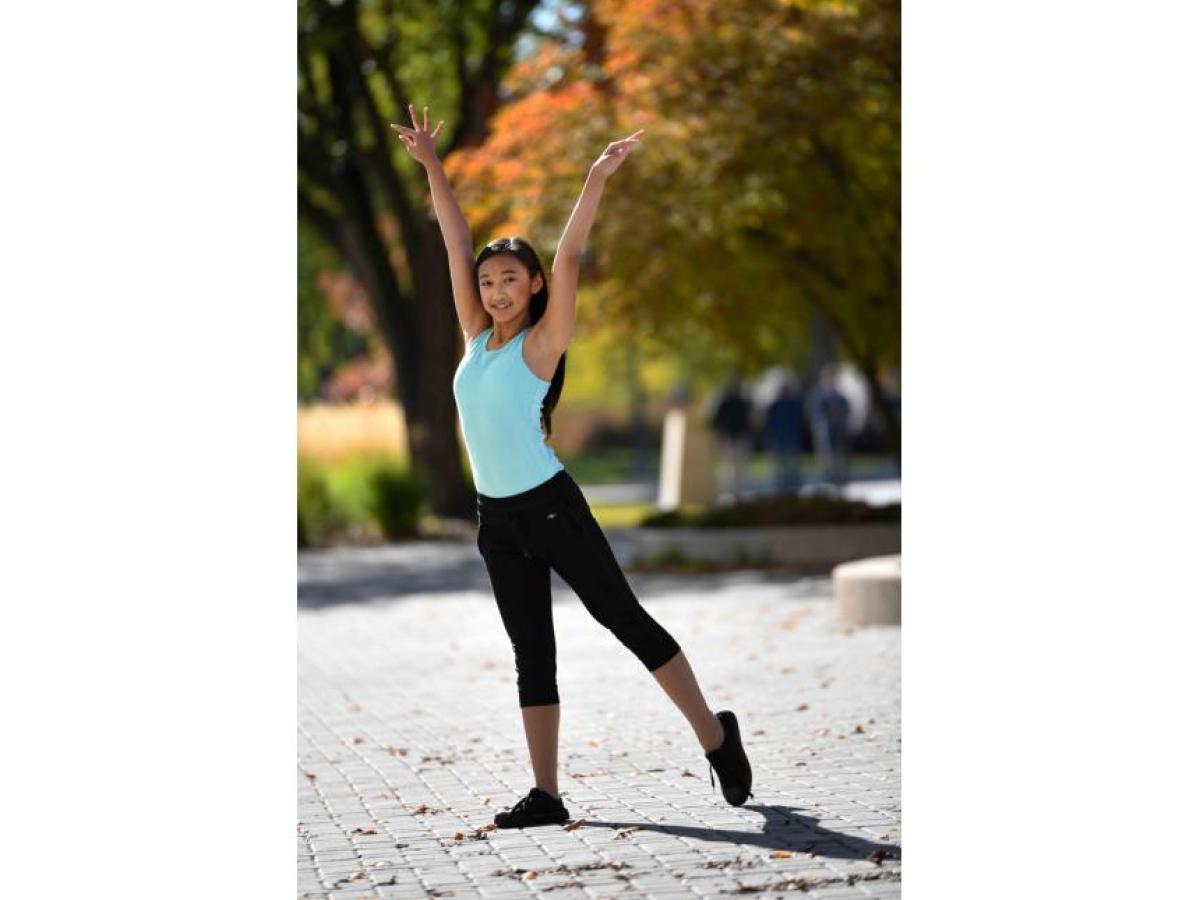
[391,103,491,341]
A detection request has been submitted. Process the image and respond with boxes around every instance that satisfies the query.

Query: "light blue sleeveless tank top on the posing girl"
[454,326,564,497]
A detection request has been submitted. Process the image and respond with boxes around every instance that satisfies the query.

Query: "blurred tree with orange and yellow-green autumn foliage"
[448,0,900,455]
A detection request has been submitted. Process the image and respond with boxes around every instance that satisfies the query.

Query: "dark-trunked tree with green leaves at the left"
[298,0,538,516]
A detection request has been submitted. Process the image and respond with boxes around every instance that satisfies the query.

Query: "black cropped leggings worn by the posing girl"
[476,469,679,707]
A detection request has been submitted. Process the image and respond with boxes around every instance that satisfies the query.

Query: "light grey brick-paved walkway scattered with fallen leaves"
[296,541,901,900]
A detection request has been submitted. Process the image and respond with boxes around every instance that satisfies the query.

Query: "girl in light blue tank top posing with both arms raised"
[391,104,752,828]
